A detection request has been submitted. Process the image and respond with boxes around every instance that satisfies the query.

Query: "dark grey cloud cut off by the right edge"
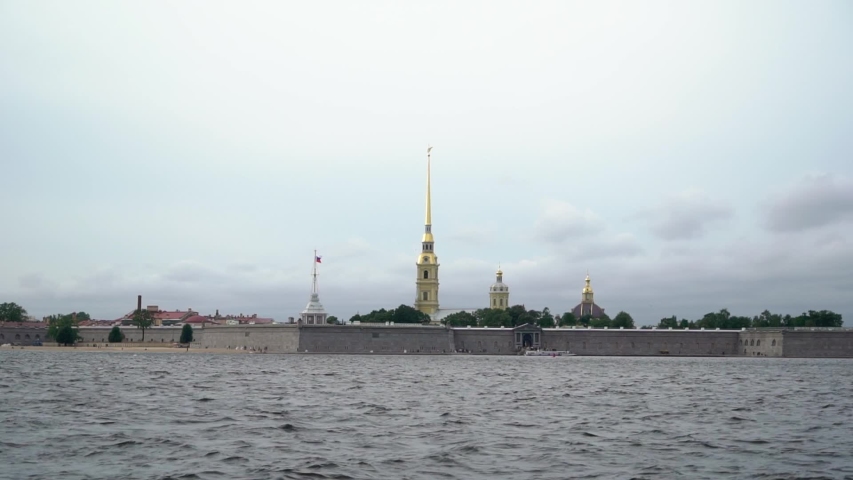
[763,175,853,233]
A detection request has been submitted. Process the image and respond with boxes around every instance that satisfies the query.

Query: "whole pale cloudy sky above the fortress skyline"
[0,1,853,324]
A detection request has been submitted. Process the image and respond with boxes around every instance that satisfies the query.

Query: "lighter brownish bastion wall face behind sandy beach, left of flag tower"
[198,324,299,353]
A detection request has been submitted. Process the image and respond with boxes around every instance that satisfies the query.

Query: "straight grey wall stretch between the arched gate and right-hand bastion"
[542,328,740,356]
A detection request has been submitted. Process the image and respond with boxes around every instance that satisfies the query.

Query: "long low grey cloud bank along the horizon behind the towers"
[16,229,853,325]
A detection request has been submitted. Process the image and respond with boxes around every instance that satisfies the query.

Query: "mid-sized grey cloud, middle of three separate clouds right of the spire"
[638,190,734,240]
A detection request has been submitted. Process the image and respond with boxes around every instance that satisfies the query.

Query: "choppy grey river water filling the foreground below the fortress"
[0,350,853,480]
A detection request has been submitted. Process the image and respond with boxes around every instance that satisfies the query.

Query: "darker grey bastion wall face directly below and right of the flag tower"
[299,324,454,355]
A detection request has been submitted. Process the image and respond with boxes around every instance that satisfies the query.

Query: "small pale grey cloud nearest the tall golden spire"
[534,201,605,244]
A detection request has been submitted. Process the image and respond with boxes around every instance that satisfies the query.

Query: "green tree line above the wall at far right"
[656,308,844,330]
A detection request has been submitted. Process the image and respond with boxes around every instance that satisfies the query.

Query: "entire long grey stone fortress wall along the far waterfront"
[0,324,853,358]
